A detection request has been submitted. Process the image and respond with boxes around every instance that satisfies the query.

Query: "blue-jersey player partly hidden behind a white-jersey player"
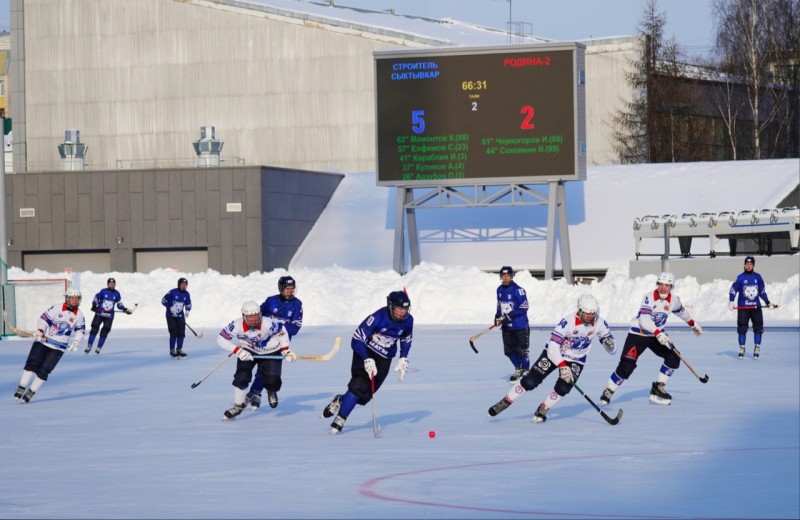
[247,276,303,411]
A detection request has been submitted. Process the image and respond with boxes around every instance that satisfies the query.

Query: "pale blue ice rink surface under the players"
[0,325,800,519]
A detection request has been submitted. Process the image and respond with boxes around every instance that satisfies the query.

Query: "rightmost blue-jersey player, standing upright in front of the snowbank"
[729,256,777,359]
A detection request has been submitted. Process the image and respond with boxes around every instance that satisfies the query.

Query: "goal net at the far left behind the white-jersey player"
[8,278,70,330]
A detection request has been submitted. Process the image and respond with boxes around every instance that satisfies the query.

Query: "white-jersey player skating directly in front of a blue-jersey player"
[217,301,297,419]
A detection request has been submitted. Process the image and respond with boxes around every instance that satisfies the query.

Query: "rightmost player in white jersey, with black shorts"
[600,272,703,405]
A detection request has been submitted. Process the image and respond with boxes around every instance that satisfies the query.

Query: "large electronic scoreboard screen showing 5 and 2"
[373,42,586,186]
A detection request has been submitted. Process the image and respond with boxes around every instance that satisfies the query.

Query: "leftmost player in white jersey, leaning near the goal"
[14,288,86,403]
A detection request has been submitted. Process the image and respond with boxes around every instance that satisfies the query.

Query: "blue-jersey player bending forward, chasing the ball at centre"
[322,291,414,435]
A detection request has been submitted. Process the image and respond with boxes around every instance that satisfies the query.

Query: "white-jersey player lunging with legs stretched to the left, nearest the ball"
[489,294,617,423]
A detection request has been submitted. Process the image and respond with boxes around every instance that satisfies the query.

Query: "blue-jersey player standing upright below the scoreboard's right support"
[494,265,531,382]
